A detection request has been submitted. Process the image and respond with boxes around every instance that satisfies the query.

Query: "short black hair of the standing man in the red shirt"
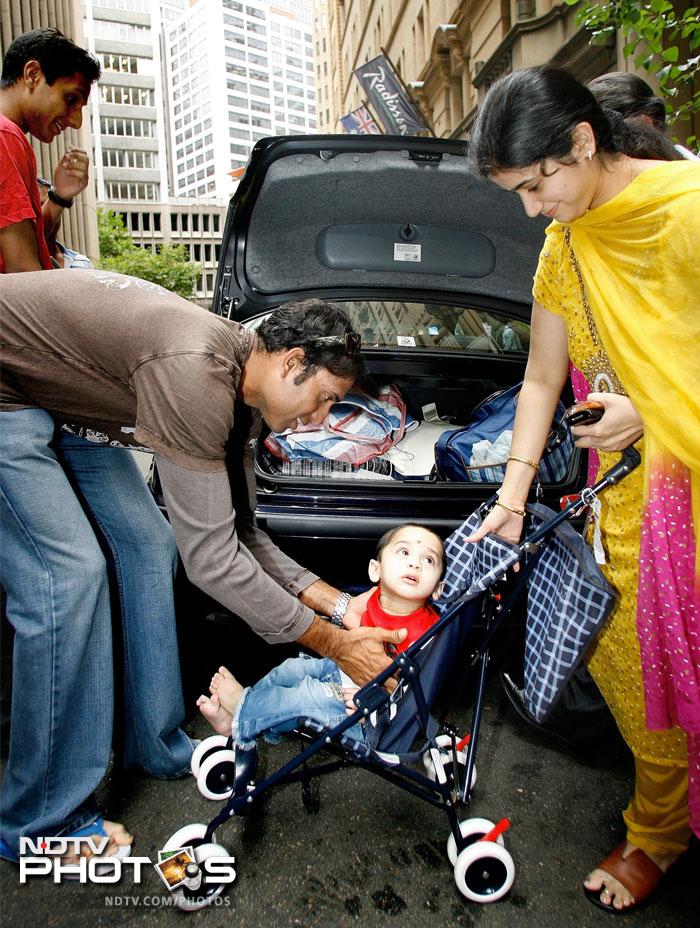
[0,29,101,87]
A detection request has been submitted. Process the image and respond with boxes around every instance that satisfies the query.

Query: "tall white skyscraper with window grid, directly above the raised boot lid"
[164,0,316,197]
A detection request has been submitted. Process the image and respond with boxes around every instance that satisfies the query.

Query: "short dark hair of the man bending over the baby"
[255,300,364,383]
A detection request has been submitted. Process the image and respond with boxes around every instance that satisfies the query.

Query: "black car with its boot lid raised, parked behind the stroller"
[214,135,583,583]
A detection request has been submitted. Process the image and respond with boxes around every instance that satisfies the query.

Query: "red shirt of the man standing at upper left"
[0,114,53,274]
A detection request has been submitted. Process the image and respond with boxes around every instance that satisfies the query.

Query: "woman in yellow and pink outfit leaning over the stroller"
[470,67,700,911]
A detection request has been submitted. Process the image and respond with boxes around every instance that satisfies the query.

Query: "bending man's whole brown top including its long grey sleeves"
[0,270,318,642]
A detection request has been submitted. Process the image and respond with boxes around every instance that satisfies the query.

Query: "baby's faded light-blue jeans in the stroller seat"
[232,654,364,748]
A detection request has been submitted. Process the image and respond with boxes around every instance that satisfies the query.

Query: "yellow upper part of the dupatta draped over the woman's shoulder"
[568,161,700,577]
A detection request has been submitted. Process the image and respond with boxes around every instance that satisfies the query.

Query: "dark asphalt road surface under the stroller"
[0,664,700,928]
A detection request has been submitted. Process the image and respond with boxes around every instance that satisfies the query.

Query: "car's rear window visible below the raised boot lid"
[335,300,530,354]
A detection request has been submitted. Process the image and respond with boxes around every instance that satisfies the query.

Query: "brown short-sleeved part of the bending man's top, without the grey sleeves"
[0,270,250,471]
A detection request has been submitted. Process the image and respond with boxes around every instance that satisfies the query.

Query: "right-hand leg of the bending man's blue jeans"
[58,432,192,777]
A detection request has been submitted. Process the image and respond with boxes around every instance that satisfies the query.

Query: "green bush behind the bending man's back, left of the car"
[97,209,201,298]
